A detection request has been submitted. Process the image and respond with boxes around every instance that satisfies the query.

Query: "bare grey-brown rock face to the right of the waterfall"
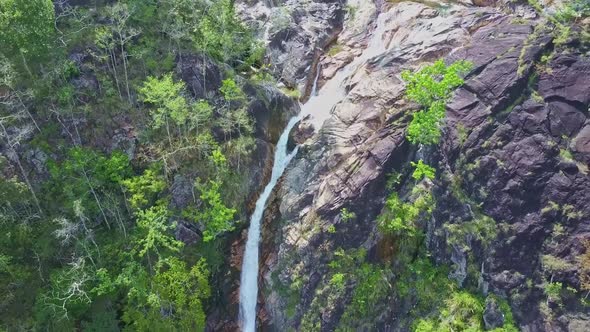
[254,1,590,331]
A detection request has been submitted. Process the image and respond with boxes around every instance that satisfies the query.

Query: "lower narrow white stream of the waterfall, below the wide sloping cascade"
[240,116,299,332]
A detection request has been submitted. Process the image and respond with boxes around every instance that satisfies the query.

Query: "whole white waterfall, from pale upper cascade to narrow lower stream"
[240,11,387,332]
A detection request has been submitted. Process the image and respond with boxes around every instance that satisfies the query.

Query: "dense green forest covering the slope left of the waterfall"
[0,0,270,331]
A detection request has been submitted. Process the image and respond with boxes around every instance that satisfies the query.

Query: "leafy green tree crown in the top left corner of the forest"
[0,0,55,76]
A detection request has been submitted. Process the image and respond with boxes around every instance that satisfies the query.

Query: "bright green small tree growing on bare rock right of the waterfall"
[402,59,472,144]
